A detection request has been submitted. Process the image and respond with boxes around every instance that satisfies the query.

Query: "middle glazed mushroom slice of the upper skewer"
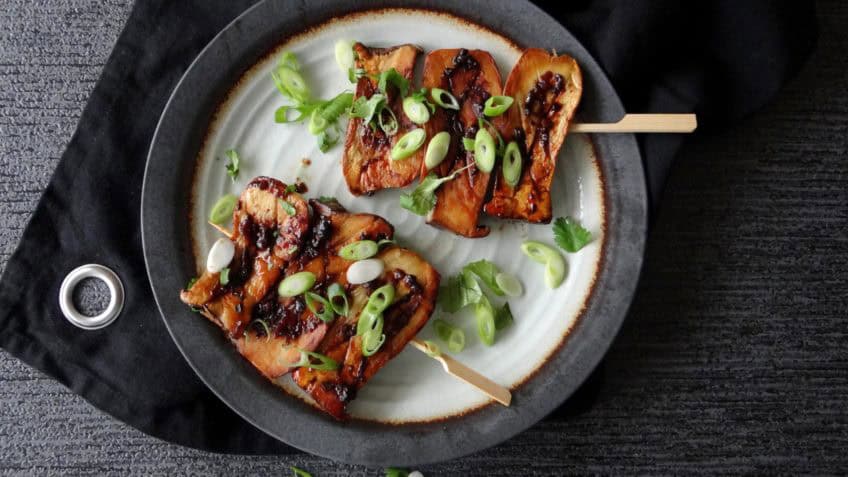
[419,49,503,237]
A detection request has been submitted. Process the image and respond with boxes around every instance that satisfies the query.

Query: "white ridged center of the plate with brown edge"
[191,10,605,423]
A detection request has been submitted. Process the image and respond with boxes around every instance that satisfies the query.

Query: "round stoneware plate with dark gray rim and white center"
[141,0,647,466]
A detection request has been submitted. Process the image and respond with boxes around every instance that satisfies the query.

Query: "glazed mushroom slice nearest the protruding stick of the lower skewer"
[293,246,439,420]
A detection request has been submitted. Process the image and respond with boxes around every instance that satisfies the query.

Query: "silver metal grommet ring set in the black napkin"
[59,263,124,330]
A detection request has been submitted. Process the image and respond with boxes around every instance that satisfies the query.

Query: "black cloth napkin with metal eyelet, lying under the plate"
[0,0,817,453]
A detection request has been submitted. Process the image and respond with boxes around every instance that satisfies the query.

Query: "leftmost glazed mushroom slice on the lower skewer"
[180,177,318,377]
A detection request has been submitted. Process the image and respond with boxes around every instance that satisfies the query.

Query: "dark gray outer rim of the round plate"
[141,0,647,465]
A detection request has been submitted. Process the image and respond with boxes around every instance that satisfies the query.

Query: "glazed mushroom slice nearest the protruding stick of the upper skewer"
[484,48,583,223]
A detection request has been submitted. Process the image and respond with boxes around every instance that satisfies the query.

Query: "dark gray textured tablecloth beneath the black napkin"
[0,0,848,477]
